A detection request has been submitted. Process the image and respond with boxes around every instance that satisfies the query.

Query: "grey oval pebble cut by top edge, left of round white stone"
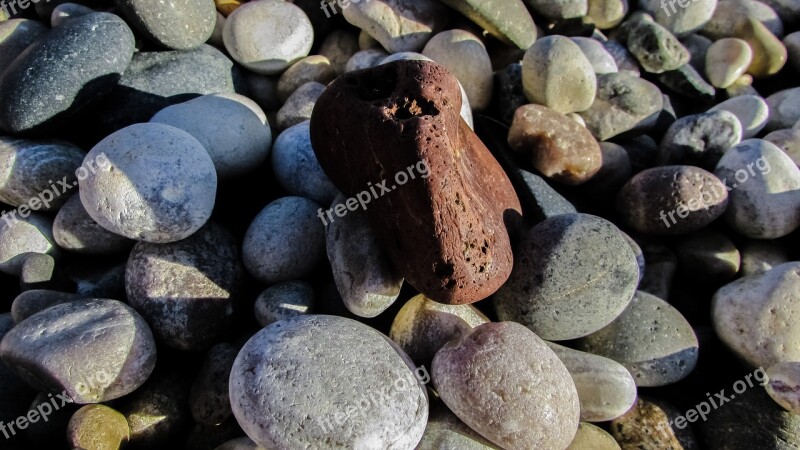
[114,0,217,50]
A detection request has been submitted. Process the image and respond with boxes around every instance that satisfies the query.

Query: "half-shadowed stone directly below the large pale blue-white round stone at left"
[53,195,132,255]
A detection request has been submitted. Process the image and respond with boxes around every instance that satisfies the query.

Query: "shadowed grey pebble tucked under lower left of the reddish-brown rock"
[325,195,403,318]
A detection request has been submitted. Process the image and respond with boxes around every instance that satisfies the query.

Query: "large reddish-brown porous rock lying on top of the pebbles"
[311,61,521,304]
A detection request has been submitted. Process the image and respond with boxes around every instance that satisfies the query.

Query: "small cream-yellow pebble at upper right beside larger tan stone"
[705,38,753,89]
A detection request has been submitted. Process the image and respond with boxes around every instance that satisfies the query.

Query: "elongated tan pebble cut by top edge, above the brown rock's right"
[442,0,536,50]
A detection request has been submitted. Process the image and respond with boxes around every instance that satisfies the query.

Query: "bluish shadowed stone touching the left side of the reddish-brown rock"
[271,120,339,205]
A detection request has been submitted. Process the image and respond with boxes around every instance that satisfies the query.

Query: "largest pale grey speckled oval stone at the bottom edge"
[230,315,428,449]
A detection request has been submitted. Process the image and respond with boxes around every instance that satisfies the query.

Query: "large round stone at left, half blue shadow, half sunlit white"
[79,123,217,243]
